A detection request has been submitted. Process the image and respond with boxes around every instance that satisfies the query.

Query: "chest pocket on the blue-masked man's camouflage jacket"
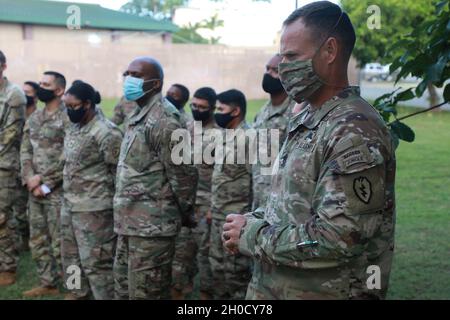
[124,129,158,172]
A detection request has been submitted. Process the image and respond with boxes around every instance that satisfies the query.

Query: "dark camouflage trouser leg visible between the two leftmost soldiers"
[14,182,30,244]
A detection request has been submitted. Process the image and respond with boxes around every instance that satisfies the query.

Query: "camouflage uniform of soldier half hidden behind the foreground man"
[252,97,295,210]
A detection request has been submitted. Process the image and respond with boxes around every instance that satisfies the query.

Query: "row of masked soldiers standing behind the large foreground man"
[0,48,295,299]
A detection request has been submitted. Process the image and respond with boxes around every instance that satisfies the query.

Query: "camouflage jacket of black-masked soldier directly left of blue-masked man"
[63,112,122,212]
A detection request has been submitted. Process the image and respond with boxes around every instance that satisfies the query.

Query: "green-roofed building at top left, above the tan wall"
[0,0,178,45]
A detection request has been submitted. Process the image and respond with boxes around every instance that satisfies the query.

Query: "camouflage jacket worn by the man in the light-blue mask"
[114,94,198,237]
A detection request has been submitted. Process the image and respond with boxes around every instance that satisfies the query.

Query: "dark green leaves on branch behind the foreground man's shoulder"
[374,0,450,144]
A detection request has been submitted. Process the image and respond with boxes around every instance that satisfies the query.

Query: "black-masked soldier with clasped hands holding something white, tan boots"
[20,71,69,297]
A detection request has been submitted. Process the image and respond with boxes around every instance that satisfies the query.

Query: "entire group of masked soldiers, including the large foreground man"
[0,1,396,299]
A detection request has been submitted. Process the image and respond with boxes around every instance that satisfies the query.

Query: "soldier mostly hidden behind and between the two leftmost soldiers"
[14,81,39,251]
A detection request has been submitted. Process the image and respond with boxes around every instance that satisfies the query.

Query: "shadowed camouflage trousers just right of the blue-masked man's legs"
[172,207,212,294]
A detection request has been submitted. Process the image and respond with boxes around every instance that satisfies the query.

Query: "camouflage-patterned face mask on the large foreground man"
[278,59,324,103]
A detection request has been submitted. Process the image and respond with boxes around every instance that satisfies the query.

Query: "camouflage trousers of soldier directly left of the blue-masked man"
[61,206,117,300]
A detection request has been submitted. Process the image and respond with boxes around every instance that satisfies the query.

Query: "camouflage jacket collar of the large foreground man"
[289,86,360,132]
